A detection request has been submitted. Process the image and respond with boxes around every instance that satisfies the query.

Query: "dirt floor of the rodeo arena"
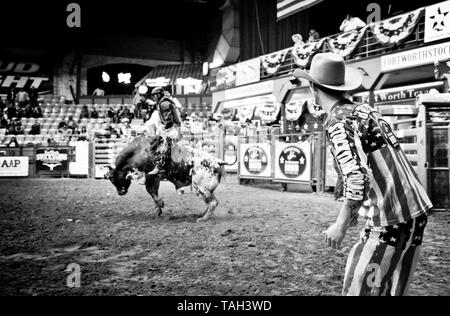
[0,179,450,296]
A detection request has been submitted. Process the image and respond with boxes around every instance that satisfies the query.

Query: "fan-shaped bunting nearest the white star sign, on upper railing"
[371,8,423,45]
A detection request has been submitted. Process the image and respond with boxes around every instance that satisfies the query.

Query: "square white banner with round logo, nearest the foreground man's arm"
[274,140,312,182]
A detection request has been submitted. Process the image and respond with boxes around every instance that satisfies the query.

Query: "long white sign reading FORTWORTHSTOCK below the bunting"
[381,42,450,72]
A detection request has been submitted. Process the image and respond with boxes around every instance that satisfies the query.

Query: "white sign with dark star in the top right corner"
[424,1,450,43]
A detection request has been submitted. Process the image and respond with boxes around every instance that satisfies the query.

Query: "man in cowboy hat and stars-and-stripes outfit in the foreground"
[293,53,432,296]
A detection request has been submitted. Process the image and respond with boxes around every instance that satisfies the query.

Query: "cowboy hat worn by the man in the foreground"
[292,53,362,91]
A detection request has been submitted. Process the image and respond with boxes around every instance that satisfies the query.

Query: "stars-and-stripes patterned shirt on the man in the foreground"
[324,100,432,227]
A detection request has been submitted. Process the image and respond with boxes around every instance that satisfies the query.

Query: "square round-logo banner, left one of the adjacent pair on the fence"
[239,143,272,178]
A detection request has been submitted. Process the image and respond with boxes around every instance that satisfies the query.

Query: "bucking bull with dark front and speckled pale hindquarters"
[105,136,234,221]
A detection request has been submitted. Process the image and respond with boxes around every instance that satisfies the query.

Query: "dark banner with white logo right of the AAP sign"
[36,147,71,173]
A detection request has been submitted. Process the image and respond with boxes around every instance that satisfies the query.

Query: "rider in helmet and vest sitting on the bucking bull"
[146,87,181,175]
